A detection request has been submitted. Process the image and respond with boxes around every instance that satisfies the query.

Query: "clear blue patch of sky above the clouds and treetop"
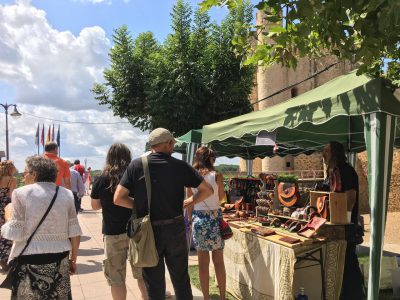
[32,0,231,41]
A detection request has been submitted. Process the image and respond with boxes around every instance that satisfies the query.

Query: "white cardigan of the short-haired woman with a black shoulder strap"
[1,182,82,261]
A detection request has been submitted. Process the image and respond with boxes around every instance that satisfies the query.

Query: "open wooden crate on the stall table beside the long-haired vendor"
[310,191,348,224]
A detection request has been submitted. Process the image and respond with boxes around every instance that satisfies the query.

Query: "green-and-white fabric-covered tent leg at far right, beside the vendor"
[364,112,397,300]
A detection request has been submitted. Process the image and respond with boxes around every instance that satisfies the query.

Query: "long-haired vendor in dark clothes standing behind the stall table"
[323,141,364,300]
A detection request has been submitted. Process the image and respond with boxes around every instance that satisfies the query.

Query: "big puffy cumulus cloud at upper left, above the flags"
[0,1,110,110]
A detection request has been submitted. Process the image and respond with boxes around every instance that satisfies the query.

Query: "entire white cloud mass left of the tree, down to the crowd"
[0,0,147,171]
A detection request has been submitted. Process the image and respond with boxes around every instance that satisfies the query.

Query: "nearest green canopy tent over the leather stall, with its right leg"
[202,72,400,299]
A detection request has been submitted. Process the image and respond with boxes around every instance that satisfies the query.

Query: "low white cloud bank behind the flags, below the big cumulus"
[0,105,147,170]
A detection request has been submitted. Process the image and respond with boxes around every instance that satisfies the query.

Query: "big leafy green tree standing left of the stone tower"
[92,0,255,135]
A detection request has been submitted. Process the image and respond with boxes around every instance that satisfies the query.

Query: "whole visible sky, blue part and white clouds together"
[0,0,253,170]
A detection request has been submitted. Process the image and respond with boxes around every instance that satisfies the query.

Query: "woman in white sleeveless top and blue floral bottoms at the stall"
[187,146,226,300]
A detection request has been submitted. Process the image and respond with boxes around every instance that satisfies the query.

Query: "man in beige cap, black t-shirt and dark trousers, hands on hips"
[114,128,213,300]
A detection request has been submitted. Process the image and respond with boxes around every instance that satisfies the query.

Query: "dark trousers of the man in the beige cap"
[143,220,193,300]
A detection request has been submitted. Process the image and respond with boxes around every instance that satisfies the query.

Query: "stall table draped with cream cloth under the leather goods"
[224,228,346,300]
